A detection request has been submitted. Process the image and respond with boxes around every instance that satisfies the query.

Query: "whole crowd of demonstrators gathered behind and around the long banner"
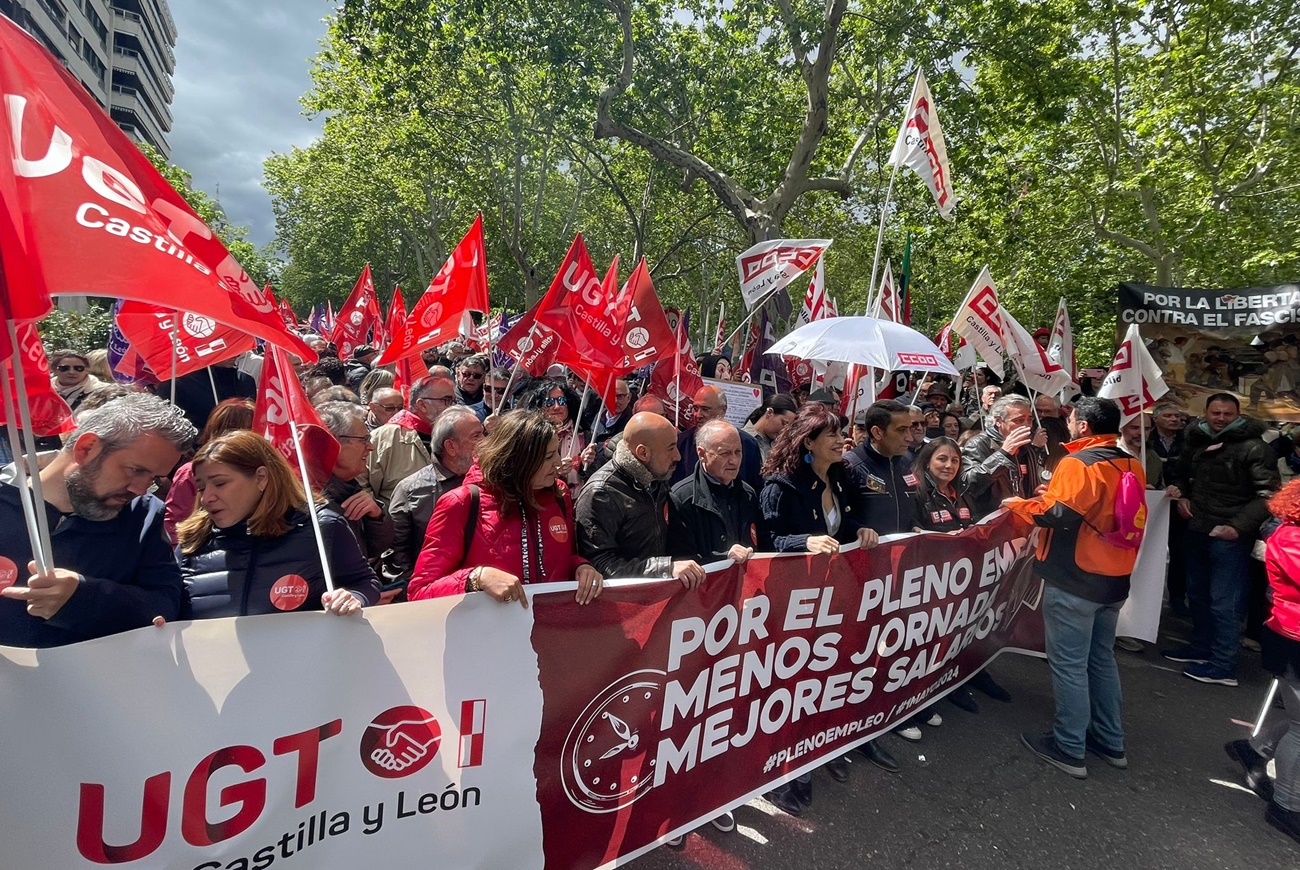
[0,336,1300,840]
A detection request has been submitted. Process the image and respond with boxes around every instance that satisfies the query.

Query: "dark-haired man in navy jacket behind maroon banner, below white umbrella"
[844,399,917,534]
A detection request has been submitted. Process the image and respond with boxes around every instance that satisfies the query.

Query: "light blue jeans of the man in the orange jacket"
[1043,584,1125,758]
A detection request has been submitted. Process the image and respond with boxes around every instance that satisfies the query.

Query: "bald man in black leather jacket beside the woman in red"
[575,411,705,589]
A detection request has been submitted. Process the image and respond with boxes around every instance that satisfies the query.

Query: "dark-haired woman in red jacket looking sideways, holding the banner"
[407,411,602,607]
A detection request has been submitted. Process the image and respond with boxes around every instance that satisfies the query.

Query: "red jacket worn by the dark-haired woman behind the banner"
[407,466,586,601]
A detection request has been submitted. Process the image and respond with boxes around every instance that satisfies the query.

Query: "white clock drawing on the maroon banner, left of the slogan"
[560,670,667,813]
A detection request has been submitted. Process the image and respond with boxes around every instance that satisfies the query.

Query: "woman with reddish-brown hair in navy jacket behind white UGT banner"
[177,432,380,619]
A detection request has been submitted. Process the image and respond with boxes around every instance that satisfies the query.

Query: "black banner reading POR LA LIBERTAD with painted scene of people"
[1115,282,1300,421]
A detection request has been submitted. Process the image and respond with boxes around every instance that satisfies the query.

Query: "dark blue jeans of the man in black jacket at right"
[1183,529,1253,676]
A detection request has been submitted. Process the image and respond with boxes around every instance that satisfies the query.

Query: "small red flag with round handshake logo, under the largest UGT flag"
[117,302,257,381]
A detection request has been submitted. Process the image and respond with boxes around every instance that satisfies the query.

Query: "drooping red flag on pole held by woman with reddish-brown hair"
[252,347,338,489]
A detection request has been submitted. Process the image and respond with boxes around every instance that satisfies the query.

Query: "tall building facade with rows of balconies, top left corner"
[0,0,176,157]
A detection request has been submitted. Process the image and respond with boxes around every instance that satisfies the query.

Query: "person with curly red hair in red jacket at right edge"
[1225,480,1300,841]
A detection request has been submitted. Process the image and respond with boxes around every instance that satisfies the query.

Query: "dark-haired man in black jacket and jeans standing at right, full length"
[1165,393,1279,685]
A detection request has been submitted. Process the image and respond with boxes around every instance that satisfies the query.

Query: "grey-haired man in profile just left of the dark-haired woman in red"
[389,404,484,585]
